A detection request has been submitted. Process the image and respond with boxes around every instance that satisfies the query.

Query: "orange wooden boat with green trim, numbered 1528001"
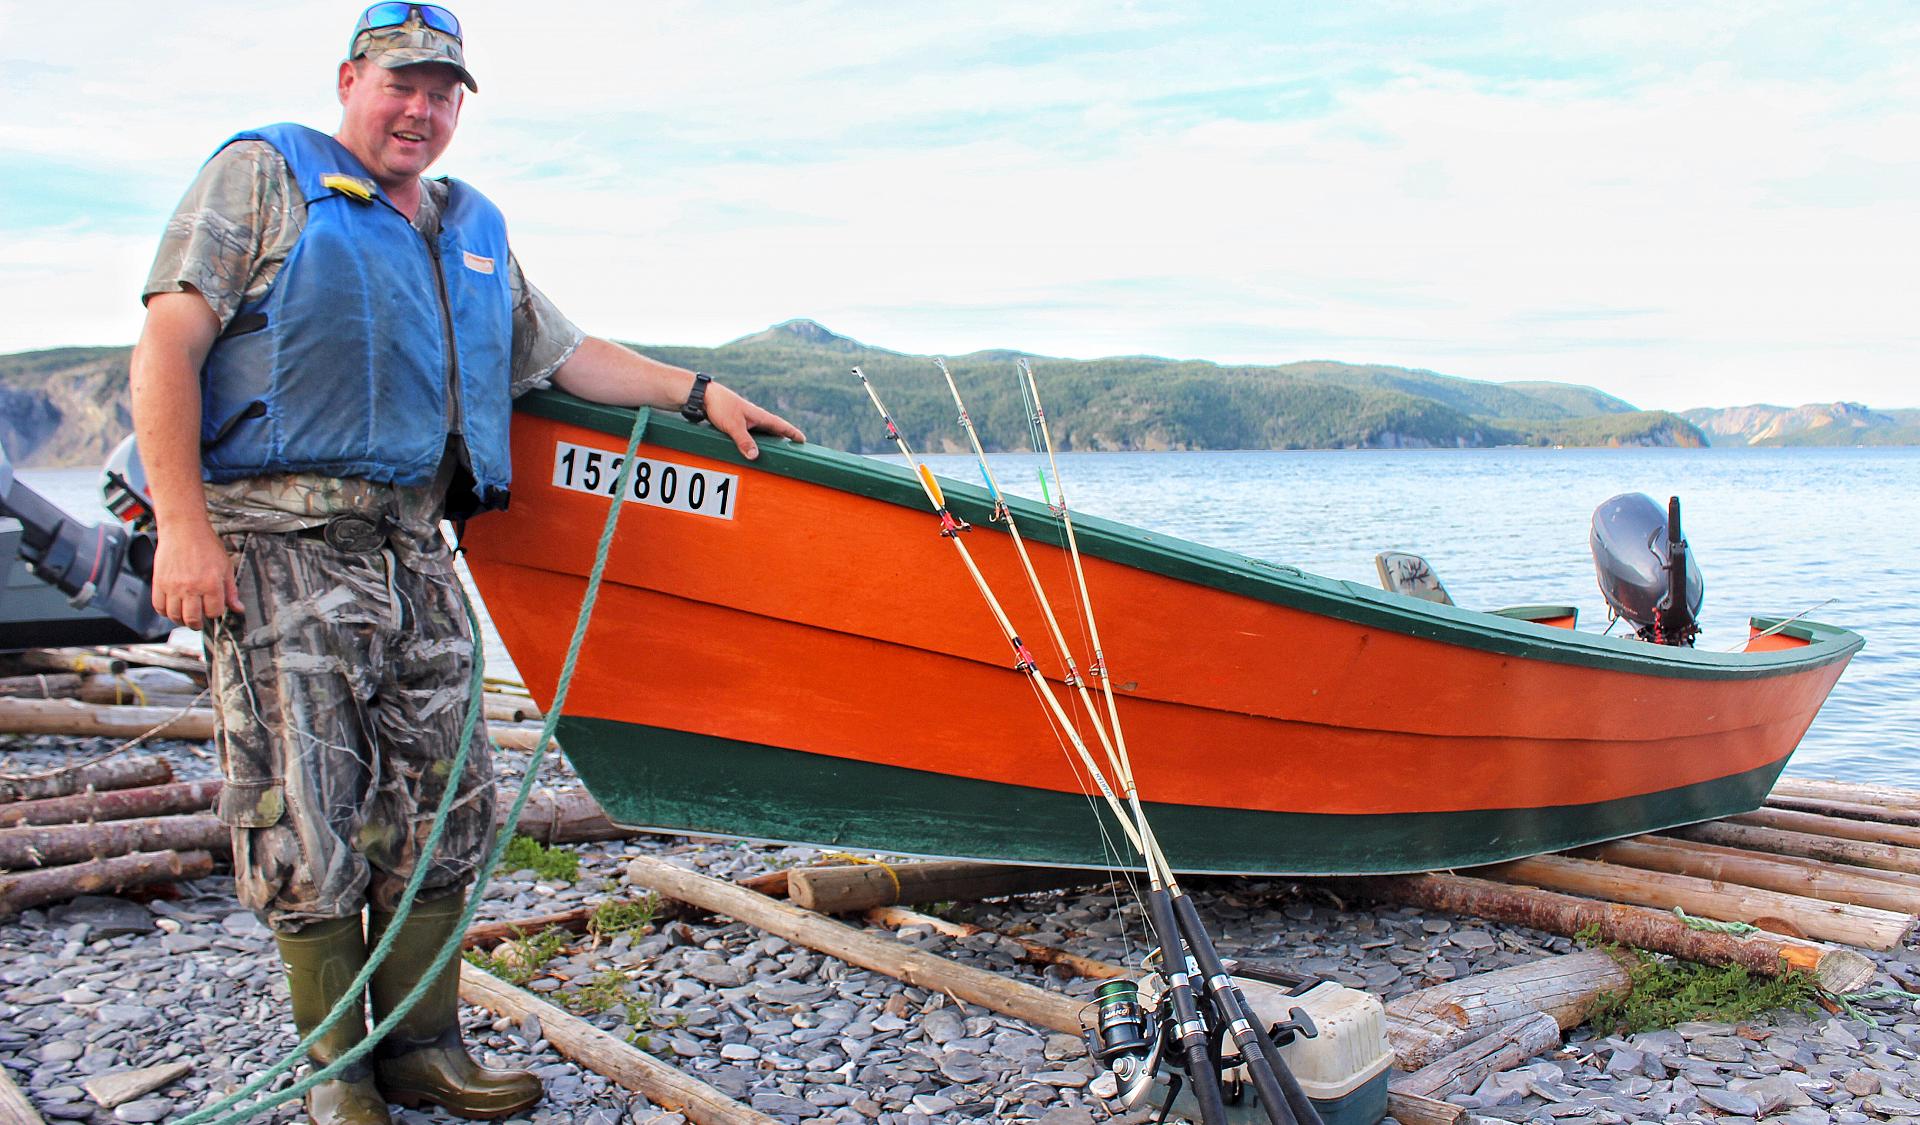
[467,392,1862,875]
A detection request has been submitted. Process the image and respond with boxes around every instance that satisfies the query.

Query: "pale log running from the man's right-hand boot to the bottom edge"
[461,962,778,1125]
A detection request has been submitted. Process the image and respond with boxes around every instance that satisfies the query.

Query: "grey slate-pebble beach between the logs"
[0,737,1920,1125]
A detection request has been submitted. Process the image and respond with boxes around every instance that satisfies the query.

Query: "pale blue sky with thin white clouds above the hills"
[0,0,1920,409]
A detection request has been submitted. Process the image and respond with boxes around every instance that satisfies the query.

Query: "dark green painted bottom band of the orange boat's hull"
[559,716,1786,875]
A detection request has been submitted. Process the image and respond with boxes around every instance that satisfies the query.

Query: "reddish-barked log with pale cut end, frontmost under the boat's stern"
[1334,875,1874,993]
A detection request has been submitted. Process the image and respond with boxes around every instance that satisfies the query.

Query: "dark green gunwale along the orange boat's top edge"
[515,390,1866,680]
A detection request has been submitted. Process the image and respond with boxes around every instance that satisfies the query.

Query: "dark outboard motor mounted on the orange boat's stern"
[1590,491,1707,645]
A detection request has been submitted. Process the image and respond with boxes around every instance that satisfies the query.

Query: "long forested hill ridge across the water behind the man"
[0,321,1707,467]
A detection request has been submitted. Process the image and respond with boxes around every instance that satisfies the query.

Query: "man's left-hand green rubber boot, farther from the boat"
[275,914,392,1125]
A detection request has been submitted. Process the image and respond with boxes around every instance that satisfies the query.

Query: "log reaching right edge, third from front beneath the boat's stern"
[1576,835,1920,914]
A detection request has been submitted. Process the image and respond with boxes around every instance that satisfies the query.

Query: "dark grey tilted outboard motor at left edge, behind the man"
[0,433,173,641]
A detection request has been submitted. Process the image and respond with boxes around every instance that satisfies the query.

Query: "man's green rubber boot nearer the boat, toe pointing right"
[367,895,541,1119]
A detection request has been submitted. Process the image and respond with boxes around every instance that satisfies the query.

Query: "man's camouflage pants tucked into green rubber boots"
[207,534,493,931]
